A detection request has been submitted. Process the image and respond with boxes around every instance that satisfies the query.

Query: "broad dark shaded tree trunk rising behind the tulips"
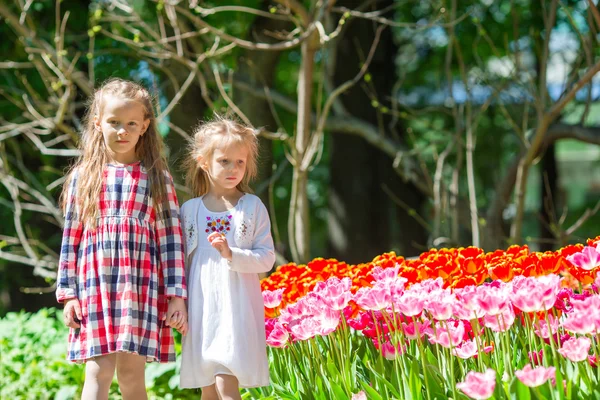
[328,1,427,263]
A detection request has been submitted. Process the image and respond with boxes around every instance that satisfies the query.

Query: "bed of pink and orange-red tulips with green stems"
[254,237,600,399]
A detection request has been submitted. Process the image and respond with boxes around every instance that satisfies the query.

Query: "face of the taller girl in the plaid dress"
[94,95,150,164]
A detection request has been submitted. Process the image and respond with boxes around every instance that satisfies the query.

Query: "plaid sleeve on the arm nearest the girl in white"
[156,173,187,299]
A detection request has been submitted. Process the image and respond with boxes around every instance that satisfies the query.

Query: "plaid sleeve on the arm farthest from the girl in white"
[56,175,83,303]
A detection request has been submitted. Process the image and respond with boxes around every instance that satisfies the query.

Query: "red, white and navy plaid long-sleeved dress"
[56,162,187,362]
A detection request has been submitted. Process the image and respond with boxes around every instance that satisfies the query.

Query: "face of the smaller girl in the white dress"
[201,144,248,190]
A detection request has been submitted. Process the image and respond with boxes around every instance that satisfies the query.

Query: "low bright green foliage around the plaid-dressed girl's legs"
[0,309,198,400]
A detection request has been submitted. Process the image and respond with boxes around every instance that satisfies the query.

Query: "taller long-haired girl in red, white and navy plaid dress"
[56,79,187,400]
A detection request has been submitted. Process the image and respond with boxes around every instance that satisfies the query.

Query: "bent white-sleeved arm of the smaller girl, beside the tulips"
[229,198,275,273]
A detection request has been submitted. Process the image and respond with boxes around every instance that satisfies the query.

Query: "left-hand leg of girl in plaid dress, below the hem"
[81,354,117,400]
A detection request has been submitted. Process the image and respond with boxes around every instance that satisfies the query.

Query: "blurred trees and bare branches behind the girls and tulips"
[0,0,600,314]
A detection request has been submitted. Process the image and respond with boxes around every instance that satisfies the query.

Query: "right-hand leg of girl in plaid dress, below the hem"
[117,353,148,400]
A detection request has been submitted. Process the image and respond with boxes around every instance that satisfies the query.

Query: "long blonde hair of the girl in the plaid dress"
[61,78,169,227]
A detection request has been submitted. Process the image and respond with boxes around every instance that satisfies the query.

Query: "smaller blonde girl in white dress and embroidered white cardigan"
[181,115,275,400]
